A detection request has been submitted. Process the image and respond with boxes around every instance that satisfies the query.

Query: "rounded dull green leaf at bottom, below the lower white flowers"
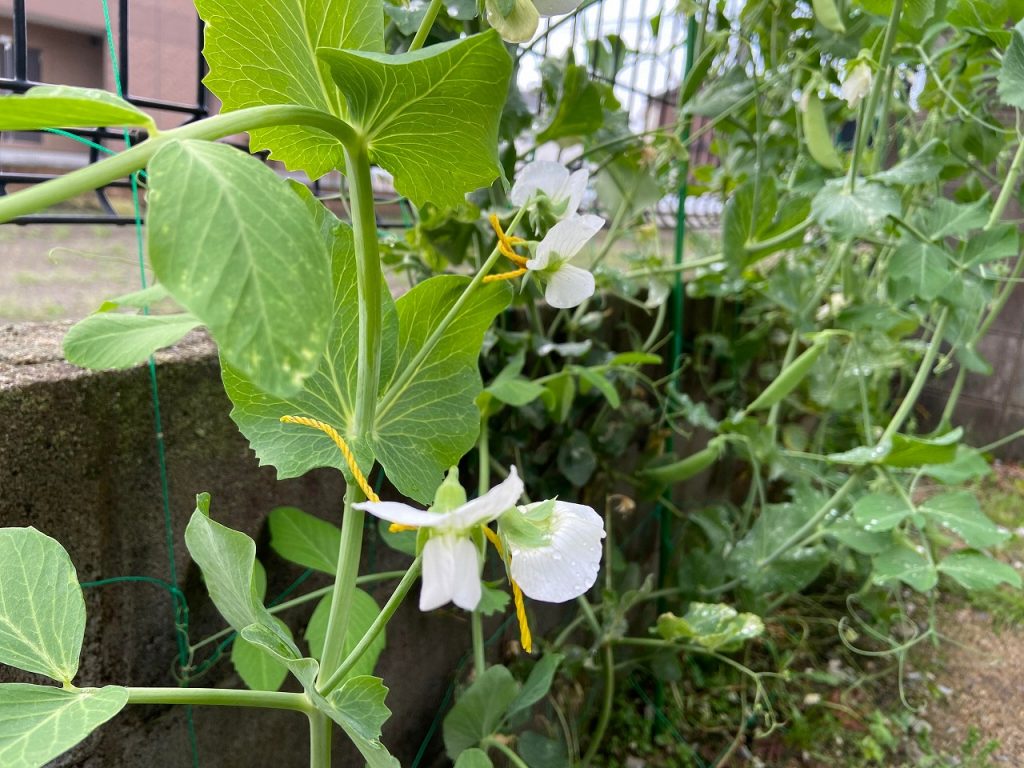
[443,665,519,760]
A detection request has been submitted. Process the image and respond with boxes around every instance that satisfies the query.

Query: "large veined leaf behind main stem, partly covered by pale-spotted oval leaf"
[221,199,398,479]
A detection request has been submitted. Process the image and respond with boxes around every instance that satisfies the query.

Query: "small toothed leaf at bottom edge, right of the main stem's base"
[312,675,400,768]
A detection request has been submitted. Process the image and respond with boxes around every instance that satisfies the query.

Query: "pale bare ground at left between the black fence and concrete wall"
[0,224,152,323]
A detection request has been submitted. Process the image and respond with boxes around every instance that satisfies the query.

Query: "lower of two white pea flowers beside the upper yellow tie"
[526,214,604,309]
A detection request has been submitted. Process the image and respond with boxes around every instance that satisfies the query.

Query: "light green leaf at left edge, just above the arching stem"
[0,85,156,131]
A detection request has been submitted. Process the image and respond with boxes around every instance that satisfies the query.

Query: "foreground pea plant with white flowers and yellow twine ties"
[0,0,630,766]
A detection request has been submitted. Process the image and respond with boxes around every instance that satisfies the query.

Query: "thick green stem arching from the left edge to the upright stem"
[0,105,358,223]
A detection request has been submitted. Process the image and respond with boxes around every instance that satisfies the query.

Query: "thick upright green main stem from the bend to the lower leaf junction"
[317,141,383,687]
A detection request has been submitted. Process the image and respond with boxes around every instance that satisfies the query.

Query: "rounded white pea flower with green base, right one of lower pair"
[498,499,604,603]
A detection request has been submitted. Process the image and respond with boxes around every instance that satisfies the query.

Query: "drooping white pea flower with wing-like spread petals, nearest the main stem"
[352,467,522,610]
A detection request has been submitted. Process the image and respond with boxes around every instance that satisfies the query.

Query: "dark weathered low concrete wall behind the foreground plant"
[0,324,469,768]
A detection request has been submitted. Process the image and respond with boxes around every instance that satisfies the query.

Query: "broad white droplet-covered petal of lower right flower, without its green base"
[509,501,604,603]
